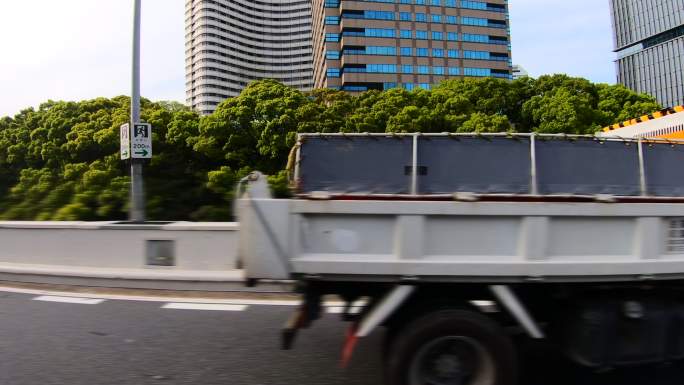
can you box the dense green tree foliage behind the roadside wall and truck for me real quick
[0,75,659,220]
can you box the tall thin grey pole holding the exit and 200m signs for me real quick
[128,0,145,222]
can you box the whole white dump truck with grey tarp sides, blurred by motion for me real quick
[238,133,684,385]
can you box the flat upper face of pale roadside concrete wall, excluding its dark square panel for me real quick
[0,222,239,273]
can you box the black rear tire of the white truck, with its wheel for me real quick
[385,309,517,385]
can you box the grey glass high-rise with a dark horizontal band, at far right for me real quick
[610,0,684,107]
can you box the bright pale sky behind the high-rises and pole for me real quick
[0,0,615,116]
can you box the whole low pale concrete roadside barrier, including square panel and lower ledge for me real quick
[0,222,243,288]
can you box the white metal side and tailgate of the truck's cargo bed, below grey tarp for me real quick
[240,199,684,282]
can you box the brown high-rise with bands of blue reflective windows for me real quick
[312,0,512,92]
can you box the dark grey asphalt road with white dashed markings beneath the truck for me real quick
[0,292,684,385]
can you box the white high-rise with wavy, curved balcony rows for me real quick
[185,0,313,114]
